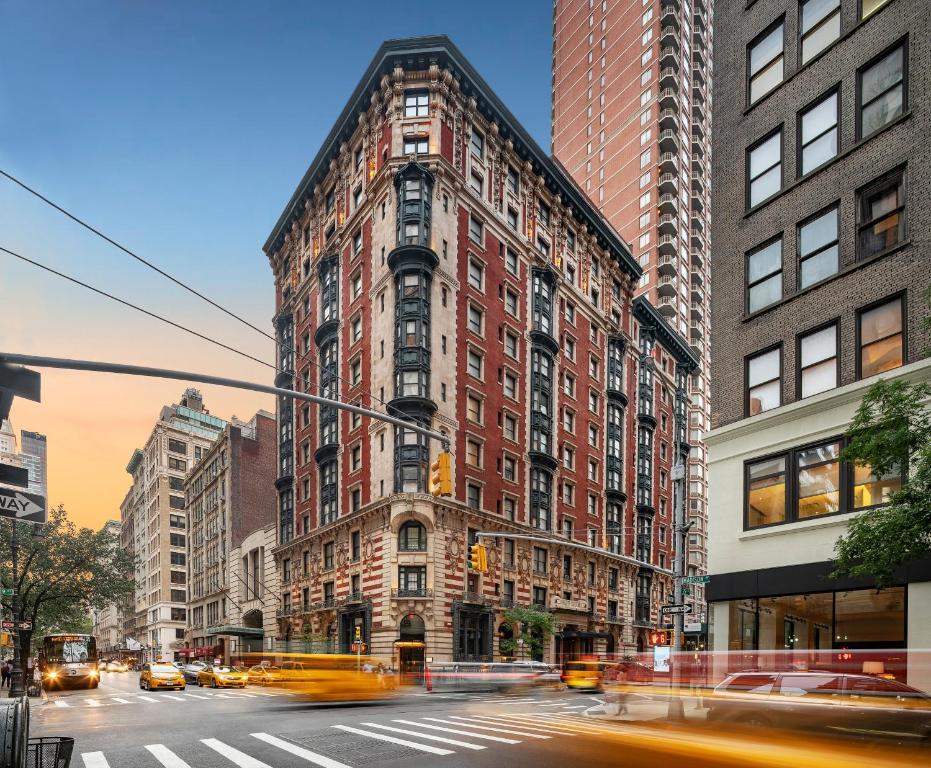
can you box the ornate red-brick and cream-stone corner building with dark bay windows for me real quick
[264,37,697,669]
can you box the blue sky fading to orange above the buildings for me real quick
[0,0,552,527]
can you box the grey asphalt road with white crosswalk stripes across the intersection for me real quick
[30,672,632,768]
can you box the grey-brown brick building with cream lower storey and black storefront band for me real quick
[706,0,931,687]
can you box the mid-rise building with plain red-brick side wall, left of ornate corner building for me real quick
[184,411,278,660]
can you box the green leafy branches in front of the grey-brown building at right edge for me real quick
[833,380,931,587]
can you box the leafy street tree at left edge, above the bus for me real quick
[0,506,135,673]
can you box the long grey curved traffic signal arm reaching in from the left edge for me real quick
[0,352,449,451]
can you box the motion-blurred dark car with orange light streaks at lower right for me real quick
[706,670,931,744]
